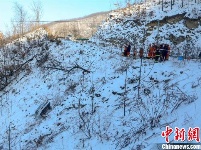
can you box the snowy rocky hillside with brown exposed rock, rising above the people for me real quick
[94,0,201,57]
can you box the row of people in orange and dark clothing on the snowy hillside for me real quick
[123,43,170,62]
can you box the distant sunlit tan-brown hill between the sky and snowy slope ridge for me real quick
[47,12,109,38]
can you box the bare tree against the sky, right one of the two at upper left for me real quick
[31,0,43,28]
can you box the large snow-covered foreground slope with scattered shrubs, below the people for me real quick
[0,0,201,150]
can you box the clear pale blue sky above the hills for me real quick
[0,0,124,32]
